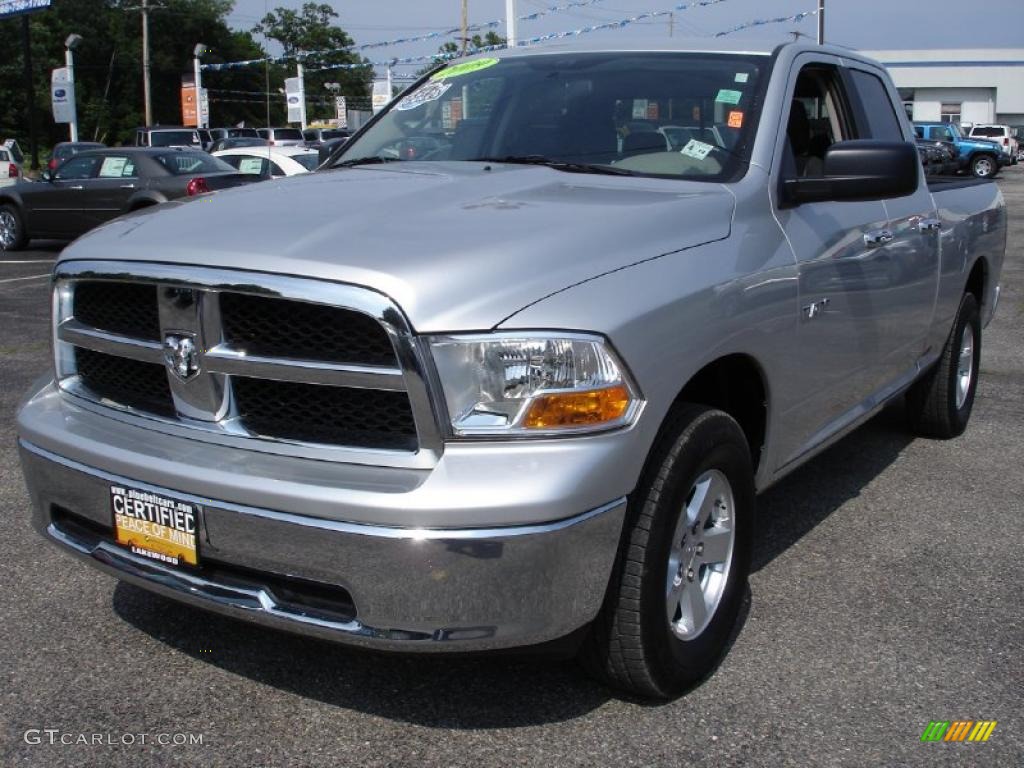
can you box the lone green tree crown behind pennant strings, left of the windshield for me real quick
[252,2,374,118]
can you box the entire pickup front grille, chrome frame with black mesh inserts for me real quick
[54,262,441,467]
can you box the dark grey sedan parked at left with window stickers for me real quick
[0,147,259,251]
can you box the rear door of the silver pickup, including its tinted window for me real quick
[847,62,939,378]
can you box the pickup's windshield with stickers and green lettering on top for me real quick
[335,52,769,181]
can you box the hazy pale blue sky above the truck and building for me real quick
[229,0,1024,78]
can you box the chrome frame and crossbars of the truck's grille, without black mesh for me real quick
[53,261,444,469]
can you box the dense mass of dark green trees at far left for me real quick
[0,0,268,146]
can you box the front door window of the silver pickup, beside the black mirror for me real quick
[783,65,850,177]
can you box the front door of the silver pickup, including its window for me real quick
[771,53,891,466]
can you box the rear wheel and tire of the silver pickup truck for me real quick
[906,293,981,439]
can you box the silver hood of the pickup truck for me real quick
[61,162,734,332]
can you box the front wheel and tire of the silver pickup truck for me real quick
[582,404,755,699]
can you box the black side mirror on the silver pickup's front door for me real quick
[782,139,921,207]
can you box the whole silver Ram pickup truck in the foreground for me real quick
[17,41,1007,697]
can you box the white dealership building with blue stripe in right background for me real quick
[866,48,1024,125]
